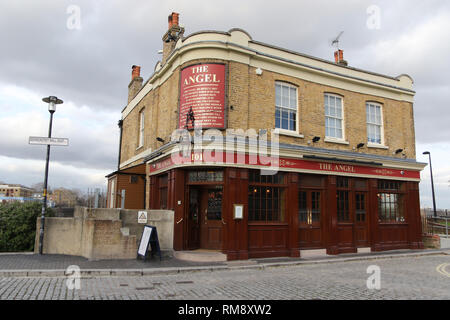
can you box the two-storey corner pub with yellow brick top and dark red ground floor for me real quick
[107,13,425,260]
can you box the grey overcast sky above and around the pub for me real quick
[0,0,450,208]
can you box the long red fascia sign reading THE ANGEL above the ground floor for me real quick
[150,151,420,180]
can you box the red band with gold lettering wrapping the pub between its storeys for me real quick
[147,150,420,182]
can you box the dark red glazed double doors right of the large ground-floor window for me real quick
[298,190,323,249]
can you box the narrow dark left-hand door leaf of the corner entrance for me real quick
[187,187,200,250]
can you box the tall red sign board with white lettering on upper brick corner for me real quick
[178,63,225,129]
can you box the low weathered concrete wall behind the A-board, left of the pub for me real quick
[35,207,174,260]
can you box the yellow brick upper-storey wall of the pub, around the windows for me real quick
[121,59,415,167]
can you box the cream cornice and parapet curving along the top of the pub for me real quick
[122,29,415,119]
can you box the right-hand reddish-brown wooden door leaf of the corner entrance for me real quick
[199,186,223,250]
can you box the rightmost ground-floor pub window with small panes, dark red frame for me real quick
[377,180,405,223]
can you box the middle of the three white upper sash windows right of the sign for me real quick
[325,93,344,139]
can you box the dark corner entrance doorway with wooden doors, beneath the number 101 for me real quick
[188,185,223,250]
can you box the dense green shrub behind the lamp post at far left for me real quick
[0,201,54,252]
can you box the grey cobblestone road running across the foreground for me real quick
[0,255,450,300]
